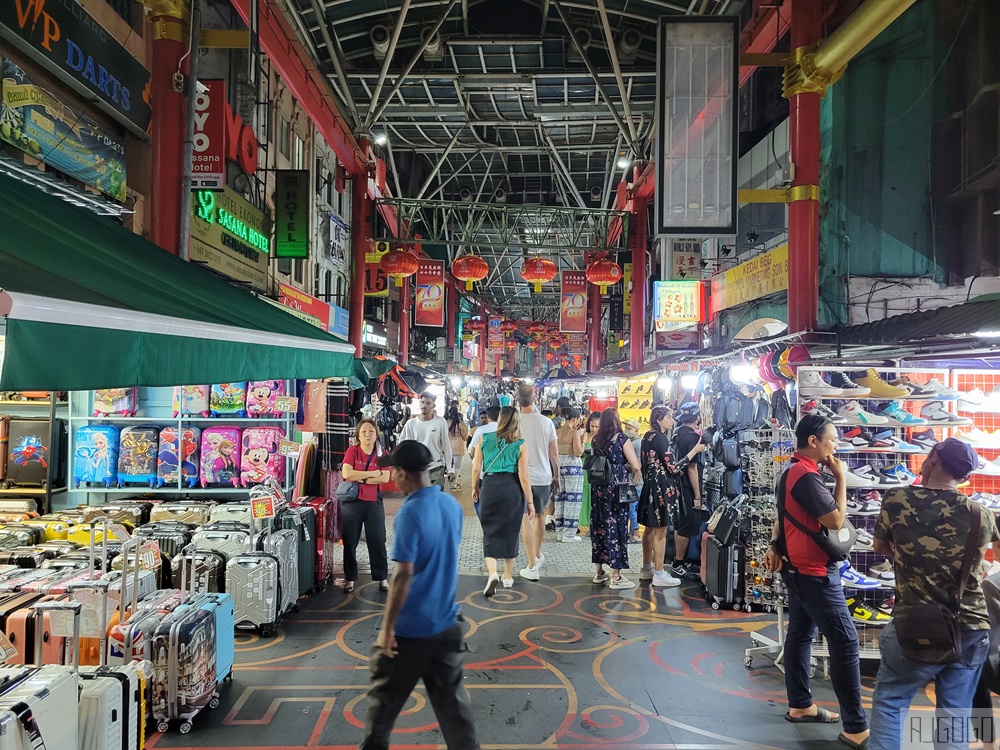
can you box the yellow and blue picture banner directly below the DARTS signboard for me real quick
[0,58,125,202]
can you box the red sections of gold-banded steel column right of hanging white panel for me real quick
[788,0,823,333]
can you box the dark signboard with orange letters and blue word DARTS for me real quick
[0,0,152,135]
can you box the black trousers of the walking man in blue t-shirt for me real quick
[360,623,479,750]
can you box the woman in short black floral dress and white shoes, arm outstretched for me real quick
[639,406,705,586]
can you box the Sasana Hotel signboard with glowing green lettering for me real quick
[189,188,271,290]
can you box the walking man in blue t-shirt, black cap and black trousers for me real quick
[360,440,479,750]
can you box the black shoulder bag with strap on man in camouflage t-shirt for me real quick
[892,507,982,664]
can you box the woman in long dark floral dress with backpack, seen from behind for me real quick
[587,409,642,589]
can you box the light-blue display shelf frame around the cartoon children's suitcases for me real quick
[67,384,295,505]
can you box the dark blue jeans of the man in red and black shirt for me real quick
[782,571,868,734]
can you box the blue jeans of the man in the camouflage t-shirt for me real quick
[868,624,990,750]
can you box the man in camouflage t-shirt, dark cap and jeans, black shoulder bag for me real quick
[869,438,1000,750]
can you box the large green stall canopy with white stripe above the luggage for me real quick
[0,175,354,390]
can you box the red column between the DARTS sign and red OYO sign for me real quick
[148,0,191,255]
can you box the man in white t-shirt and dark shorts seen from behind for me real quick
[517,384,559,581]
